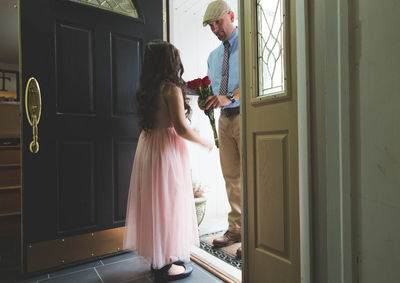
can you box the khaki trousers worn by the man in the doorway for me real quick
[218,115,242,233]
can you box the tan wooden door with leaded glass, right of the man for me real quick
[241,0,300,283]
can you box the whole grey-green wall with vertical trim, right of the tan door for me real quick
[309,0,400,283]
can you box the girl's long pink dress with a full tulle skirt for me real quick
[124,92,199,269]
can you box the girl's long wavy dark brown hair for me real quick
[136,40,191,131]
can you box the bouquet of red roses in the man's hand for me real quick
[187,76,219,148]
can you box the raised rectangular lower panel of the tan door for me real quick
[254,133,288,258]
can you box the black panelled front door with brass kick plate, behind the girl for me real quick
[20,0,163,272]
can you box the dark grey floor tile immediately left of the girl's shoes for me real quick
[96,257,150,283]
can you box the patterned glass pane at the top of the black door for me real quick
[70,0,139,19]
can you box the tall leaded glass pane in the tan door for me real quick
[257,0,286,96]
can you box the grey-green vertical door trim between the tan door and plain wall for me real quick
[307,0,353,283]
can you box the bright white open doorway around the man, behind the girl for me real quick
[169,0,242,281]
